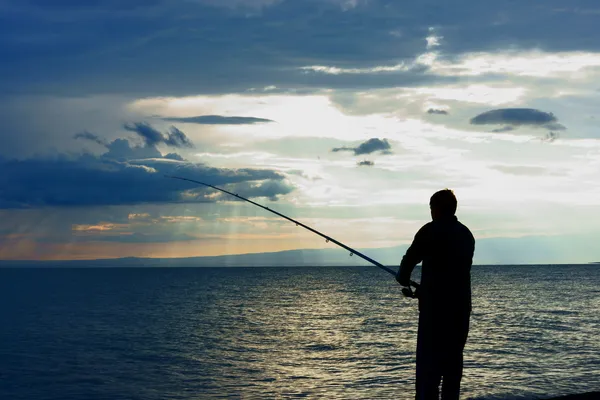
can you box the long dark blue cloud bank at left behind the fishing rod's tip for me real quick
[0,139,293,208]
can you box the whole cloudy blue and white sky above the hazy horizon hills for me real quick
[0,0,600,263]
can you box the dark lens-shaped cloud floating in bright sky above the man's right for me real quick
[471,108,558,126]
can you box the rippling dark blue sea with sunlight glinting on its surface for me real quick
[0,265,600,400]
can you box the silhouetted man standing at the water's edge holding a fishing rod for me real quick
[396,189,475,400]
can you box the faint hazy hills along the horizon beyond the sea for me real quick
[0,236,600,267]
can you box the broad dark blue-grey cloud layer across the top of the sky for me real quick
[0,0,600,95]
